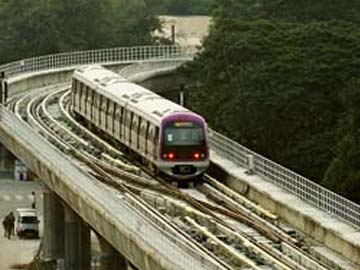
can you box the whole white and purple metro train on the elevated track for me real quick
[71,65,209,181]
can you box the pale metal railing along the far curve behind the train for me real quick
[0,45,193,77]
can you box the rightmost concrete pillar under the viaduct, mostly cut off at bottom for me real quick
[97,235,128,270]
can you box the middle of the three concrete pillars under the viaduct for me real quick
[65,206,91,270]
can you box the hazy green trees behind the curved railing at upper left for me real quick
[0,0,162,63]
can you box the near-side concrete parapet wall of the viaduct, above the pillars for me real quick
[0,108,186,270]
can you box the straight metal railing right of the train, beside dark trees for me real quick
[210,130,360,229]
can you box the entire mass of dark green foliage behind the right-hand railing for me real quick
[184,0,360,202]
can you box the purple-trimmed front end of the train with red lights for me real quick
[157,112,209,180]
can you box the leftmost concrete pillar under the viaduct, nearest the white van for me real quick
[43,188,65,261]
